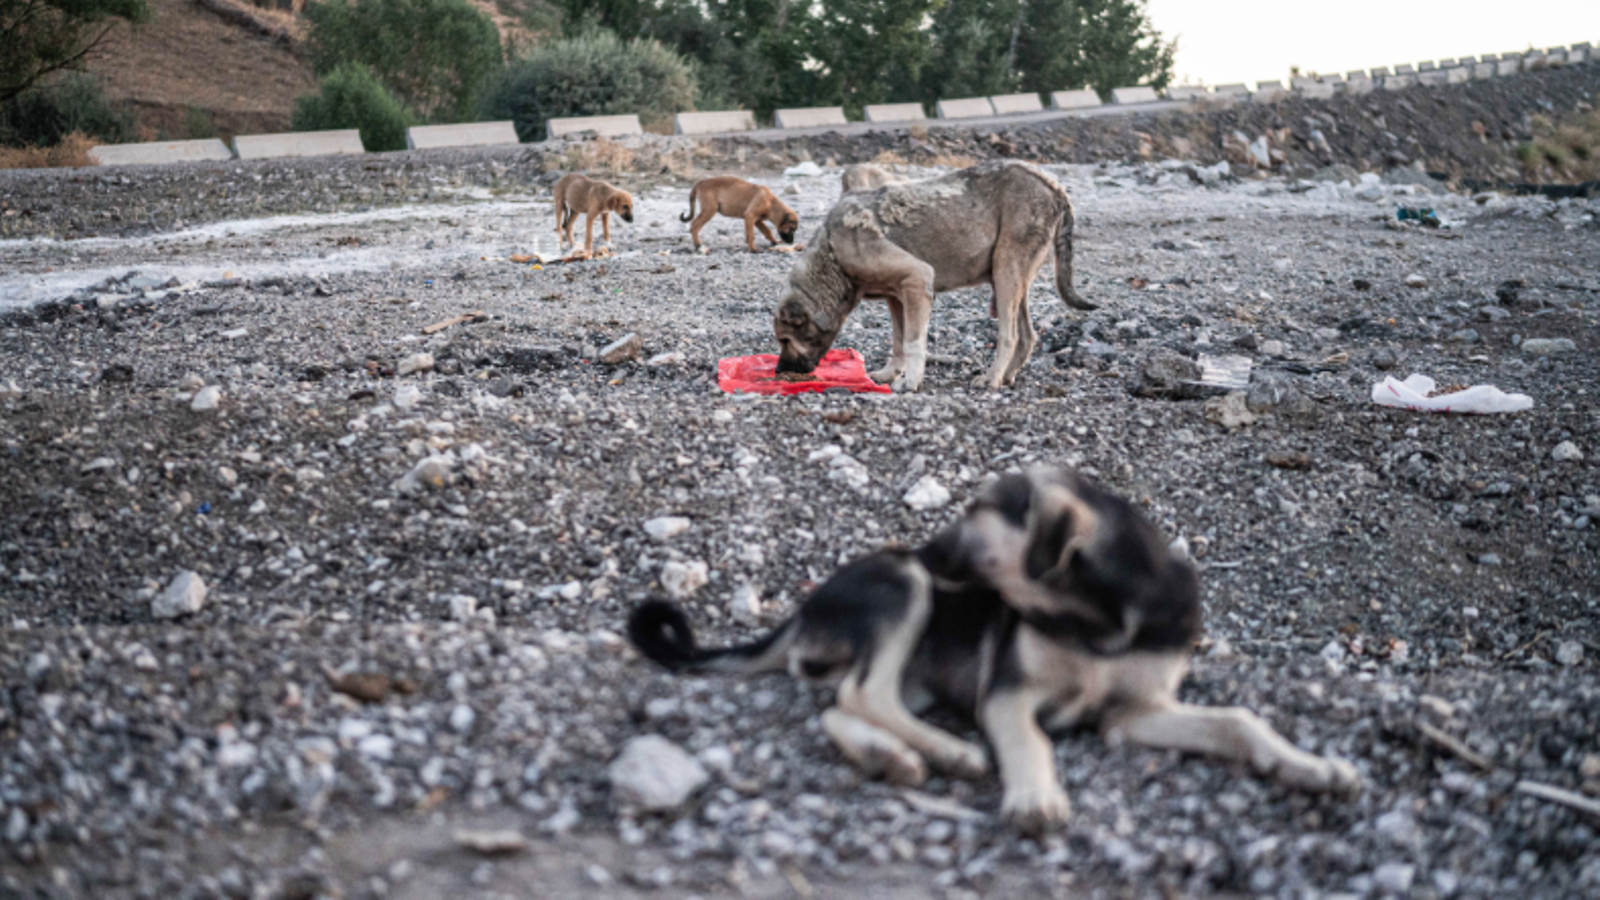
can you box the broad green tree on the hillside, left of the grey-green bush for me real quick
[300,0,504,122]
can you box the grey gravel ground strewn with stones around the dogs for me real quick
[0,150,1600,898]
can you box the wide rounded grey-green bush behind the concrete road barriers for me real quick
[480,30,696,141]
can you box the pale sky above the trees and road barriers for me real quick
[1149,0,1600,85]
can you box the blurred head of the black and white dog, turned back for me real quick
[952,466,1200,650]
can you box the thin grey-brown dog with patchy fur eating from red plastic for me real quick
[773,160,1094,391]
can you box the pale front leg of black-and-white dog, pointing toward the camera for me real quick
[979,687,1072,833]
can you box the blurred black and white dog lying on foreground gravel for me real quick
[629,468,1360,831]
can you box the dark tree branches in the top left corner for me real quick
[0,0,149,102]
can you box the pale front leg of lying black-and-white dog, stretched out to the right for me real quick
[1106,703,1362,794]
